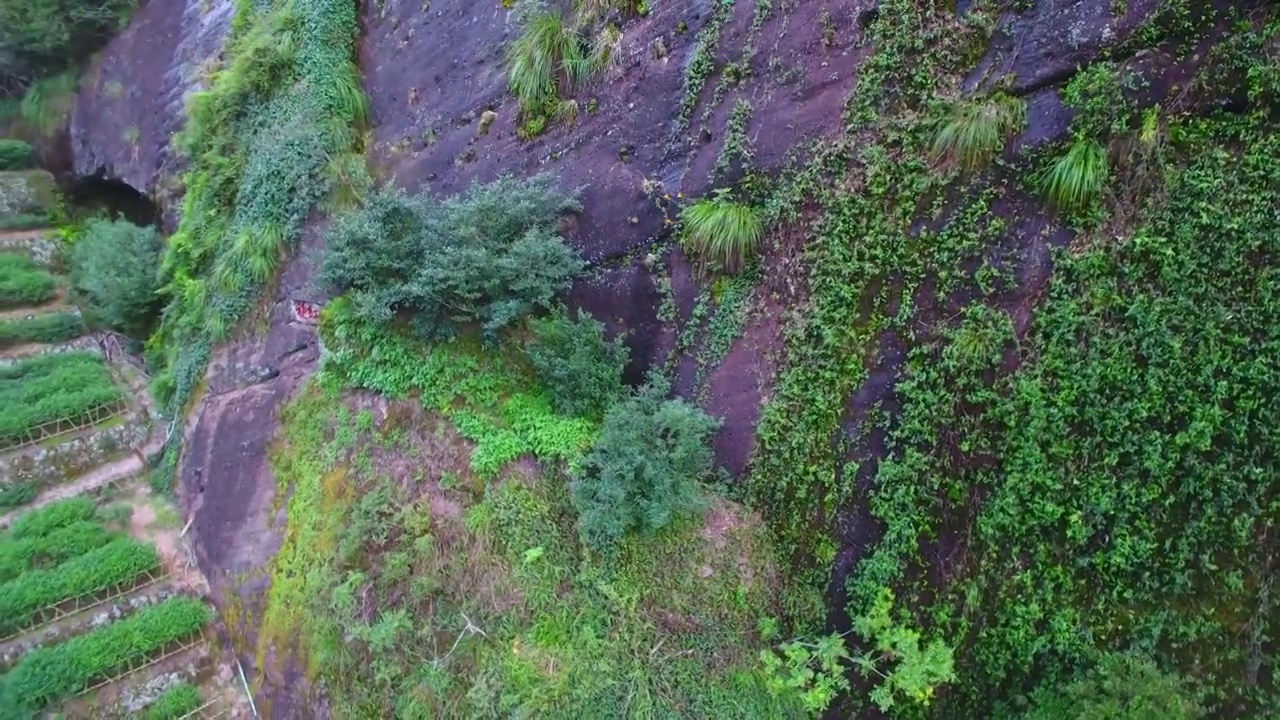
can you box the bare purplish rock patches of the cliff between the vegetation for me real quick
[72,0,1259,716]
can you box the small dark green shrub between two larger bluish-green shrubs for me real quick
[525,310,628,418]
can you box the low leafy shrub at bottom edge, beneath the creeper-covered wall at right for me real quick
[1023,652,1204,720]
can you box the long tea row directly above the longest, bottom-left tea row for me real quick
[0,538,159,634]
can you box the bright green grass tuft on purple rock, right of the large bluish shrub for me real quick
[680,190,764,273]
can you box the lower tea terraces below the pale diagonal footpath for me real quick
[0,497,243,720]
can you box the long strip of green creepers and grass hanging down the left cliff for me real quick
[147,0,369,489]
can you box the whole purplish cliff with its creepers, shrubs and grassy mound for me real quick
[0,0,1280,719]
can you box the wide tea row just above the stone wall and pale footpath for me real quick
[0,352,123,446]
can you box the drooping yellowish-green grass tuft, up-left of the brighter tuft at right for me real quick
[933,94,1027,170]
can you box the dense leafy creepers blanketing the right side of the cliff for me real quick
[748,3,1280,717]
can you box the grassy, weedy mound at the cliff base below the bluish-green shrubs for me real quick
[259,325,799,717]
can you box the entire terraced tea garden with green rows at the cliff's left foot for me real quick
[0,165,252,720]
